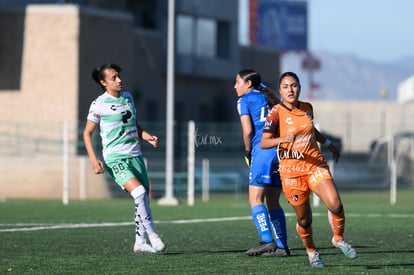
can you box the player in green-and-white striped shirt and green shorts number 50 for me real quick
[83,64,165,253]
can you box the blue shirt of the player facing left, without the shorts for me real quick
[237,90,268,152]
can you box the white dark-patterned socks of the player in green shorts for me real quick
[131,185,155,242]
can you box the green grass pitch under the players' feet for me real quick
[0,190,414,274]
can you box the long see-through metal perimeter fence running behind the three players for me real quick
[0,122,414,205]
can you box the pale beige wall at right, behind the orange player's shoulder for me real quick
[311,100,414,152]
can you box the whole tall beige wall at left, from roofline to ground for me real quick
[0,5,109,199]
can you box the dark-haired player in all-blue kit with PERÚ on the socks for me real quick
[234,69,290,256]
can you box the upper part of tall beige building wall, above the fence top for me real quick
[0,6,79,126]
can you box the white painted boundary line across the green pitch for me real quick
[0,213,414,233]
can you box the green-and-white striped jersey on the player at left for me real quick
[87,91,142,162]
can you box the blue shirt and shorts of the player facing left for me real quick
[237,90,281,187]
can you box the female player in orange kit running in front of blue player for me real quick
[261,72,357,267]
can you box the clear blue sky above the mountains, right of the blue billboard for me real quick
[308,0,414,62]
